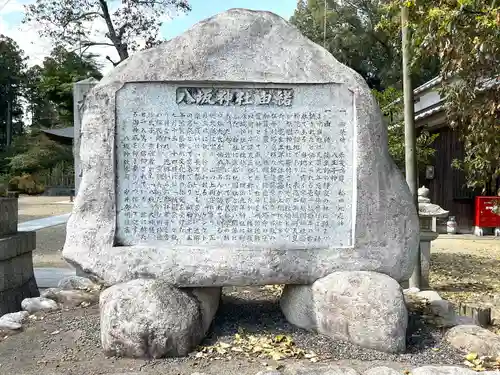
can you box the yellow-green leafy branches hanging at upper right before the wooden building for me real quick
[379,0,500,192]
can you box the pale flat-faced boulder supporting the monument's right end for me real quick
[281,271,408,353]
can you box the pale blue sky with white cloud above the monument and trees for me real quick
[0,0,297,70]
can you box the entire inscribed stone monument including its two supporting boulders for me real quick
[63,9,419,357]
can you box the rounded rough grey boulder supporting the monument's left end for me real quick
[99,279,220,358]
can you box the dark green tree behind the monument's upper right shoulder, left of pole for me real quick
[290,0,438,91]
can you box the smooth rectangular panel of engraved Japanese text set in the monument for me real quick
[116,83,356,249]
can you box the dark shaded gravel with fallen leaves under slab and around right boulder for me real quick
[199,287,457,363]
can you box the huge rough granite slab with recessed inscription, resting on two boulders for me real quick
[63,9,419,286]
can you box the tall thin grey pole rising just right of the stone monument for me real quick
[401,0,422,288]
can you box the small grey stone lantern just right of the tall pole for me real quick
[418,186,449,289]
